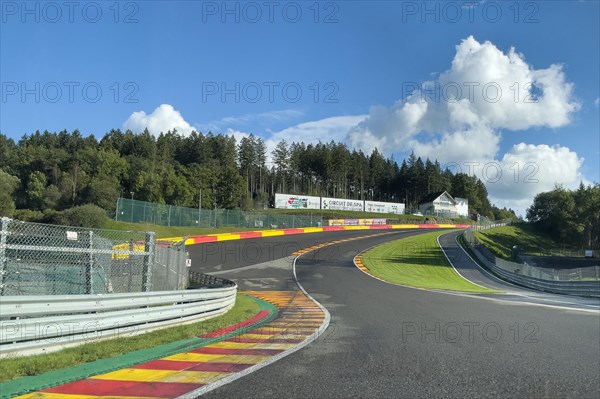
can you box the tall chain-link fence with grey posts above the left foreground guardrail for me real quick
[0,218,187,296]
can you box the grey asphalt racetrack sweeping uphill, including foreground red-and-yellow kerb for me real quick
[14,226,600,399]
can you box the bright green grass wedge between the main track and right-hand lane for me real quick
[363,232,495,293]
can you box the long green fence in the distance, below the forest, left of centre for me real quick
[115,198,323,229]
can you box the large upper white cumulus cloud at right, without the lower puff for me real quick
[347,36,581,159]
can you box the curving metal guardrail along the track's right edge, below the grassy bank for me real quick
[463,229,600,297]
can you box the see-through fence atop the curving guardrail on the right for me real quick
[463,229,600,281]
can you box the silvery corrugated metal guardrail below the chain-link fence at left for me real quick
[0,284,237,357]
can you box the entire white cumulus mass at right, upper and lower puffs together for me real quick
[346,36,583,213]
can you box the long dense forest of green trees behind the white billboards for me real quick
[0,129,515,219]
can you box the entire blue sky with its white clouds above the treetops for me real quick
[0,1,600,216]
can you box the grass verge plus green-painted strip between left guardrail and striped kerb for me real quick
[0,294,277,399]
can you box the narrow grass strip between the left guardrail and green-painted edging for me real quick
[0,295,260,381]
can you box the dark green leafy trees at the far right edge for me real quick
[527,183,600,249]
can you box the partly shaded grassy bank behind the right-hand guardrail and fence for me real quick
[475,223,569,260]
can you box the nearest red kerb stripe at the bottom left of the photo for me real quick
[42,379,205,398]
